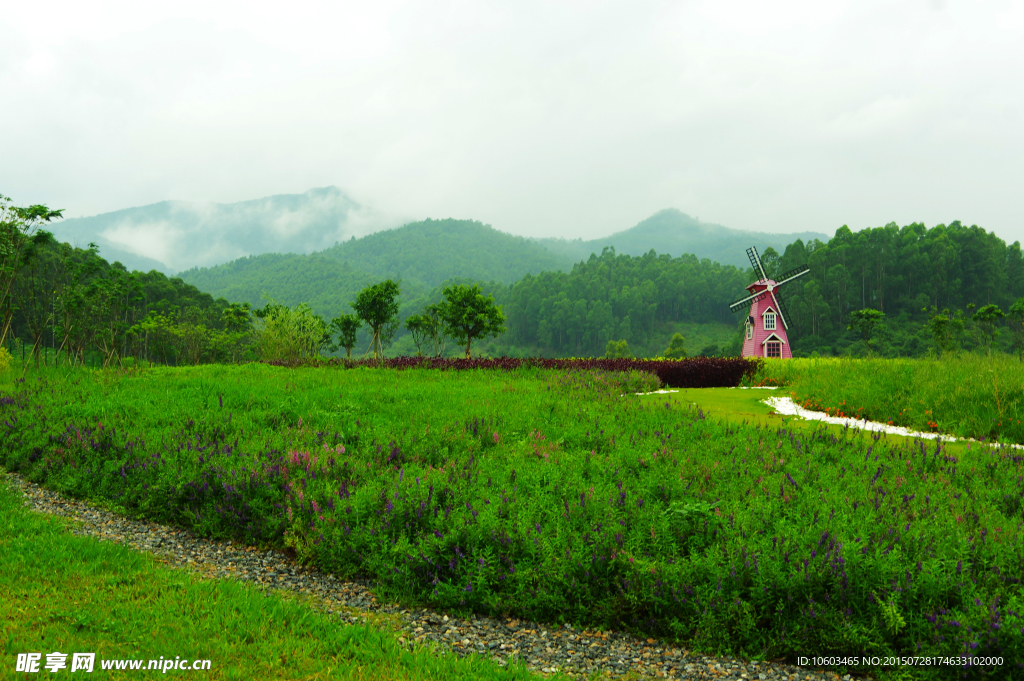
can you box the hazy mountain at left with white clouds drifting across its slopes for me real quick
[51,186,395,274]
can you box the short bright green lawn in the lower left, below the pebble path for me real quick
[0,480,552,680]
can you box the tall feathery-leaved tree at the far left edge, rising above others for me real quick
[0,195,63,345]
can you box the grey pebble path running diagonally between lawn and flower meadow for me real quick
[7,473,850,681]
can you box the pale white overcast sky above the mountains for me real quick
[0,0,1024,242]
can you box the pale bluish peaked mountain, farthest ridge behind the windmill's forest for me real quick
[535,208,829,269]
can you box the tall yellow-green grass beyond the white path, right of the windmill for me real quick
[754,353,1024,443]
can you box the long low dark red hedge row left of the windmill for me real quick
[266,357,758,388]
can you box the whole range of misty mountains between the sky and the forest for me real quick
[52,186,828,274]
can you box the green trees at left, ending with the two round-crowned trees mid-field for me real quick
[0,196,505,367]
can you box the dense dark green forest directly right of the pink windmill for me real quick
[762,221,1024,356]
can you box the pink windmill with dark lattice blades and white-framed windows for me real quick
[729,247,811,357]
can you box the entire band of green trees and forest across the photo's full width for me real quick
[8,191,1024,366]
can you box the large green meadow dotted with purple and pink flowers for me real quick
[0,365,1024,678]
